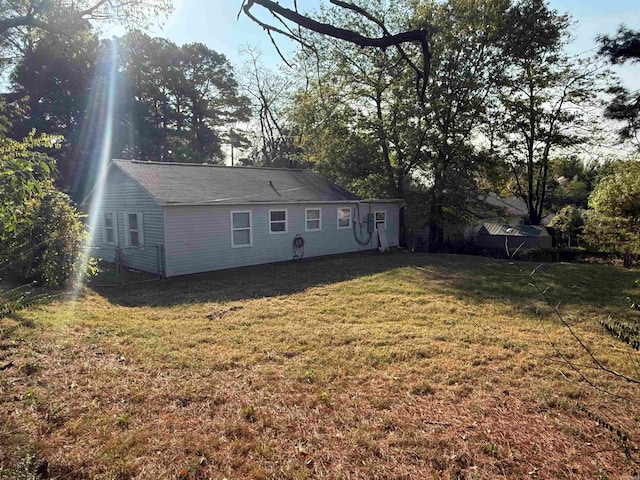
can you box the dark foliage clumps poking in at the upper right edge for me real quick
[598,26,640,148]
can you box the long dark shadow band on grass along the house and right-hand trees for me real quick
[95,252,640,312]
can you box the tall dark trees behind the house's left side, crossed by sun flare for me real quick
[4,29,250,199]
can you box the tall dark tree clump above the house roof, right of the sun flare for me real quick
[116,32,250,162]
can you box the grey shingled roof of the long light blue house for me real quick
[113,160,360,205]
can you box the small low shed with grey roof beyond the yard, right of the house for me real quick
[476,223,552,250]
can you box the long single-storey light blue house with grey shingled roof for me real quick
[89,160,401,277]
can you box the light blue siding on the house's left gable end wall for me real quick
[92,166,164,273]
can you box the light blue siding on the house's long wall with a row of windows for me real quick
[162,203,399,276]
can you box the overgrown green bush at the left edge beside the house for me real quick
[0,132,91,288]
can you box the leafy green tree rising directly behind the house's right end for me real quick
[295,0,424,198]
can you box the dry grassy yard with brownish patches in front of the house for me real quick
[0,253,640,480]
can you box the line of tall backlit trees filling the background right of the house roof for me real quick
[241,0,639,253]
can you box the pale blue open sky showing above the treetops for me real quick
[150,0,640,90]
